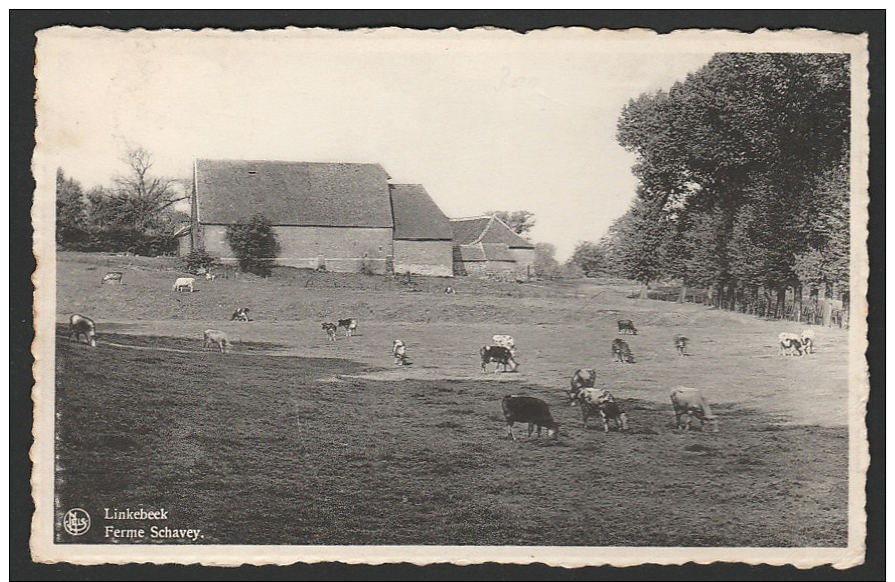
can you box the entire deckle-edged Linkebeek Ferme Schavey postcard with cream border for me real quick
[31,21,869,568]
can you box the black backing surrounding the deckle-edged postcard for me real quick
[9,10,886,580]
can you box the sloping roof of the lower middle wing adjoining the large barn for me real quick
[390,184,453,240]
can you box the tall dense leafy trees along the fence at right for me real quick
[581,53,850,322]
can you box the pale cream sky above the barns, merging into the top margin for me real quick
[37,28,714,260]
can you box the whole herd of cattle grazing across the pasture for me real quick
[69,271,815,440]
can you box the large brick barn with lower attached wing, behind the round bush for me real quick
[180,160,452,276]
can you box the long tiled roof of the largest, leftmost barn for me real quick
[195,160,393,228]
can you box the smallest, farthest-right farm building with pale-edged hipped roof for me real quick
[451,216,535,276]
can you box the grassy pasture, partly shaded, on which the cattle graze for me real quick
[56,253,848,546]
